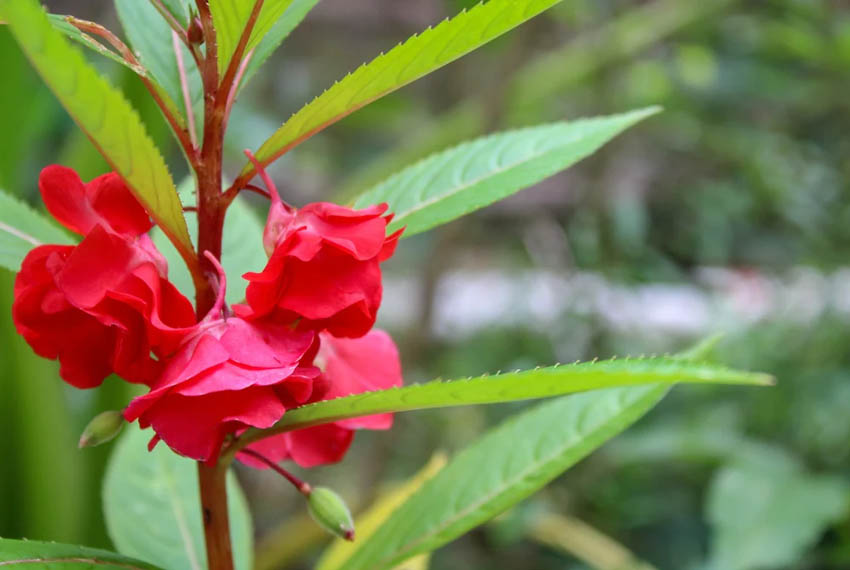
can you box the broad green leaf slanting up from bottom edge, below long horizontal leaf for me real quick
[341,386,669,570]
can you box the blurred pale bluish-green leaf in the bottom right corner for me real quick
[708,454,850,570]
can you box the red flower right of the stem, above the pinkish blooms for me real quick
[236,201,401,337]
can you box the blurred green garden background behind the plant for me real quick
[0,0,850,570]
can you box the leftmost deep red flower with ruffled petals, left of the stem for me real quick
[12,166,195,388]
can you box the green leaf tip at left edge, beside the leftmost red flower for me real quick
[0,186,73,271]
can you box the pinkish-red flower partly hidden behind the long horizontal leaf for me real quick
[237,330,402,469]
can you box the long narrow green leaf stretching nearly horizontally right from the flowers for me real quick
[241,358,772,441]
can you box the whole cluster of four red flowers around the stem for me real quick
[12,166,401,467]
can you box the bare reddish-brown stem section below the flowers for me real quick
[198,463,233,570]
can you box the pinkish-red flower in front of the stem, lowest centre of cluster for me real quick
[124,317,319,463]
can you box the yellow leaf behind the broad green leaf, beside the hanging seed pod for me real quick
[316,452,448,570]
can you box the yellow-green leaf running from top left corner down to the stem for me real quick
[0,0,196,264]
